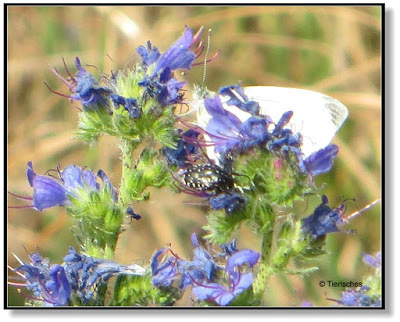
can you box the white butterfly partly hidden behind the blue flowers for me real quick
[194,86,349,158]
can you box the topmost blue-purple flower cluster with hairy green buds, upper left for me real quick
[45,27,211,147]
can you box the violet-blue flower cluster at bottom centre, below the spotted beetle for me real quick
[151,234,260,306]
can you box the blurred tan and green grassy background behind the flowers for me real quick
[7,6,382,306]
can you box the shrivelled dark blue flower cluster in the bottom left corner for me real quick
[9,247,145,306]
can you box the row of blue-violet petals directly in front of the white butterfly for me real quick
[199,85,338,177]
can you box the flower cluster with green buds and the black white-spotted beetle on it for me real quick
[164,85,338,214]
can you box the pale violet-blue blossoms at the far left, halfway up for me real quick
[21,161,117,211]
